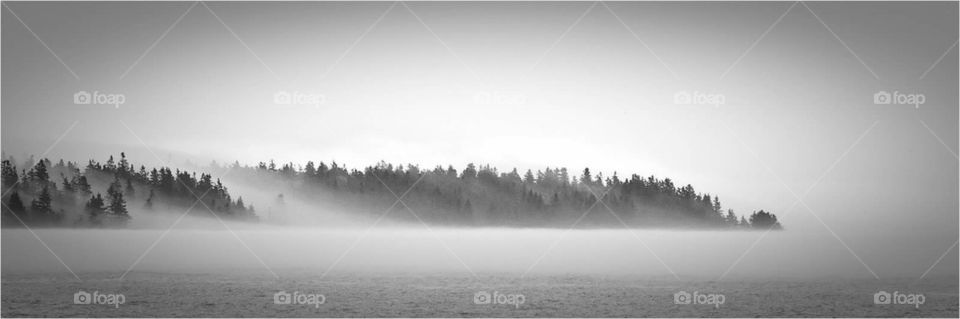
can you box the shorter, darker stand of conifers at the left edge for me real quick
[0,153,257,227]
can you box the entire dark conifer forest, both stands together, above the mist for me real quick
[2,153,782,229]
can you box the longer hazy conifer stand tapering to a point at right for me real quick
[223,161,782,229]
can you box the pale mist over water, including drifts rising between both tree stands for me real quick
[0,156,958,280]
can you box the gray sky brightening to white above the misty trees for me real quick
[2,2,958,242]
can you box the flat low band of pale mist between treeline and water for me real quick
[2,220,957,280]
